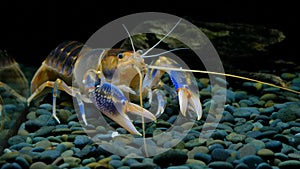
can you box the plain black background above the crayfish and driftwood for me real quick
[0,0,299,66]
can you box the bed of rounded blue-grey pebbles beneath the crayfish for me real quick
[0,73,300,169]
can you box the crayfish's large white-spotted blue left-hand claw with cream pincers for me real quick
[84,71,156,135]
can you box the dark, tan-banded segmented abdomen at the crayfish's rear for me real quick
[45,41,83,76]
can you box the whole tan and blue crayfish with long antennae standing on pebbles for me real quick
[0,18,300,139]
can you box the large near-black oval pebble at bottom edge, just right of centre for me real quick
[153,149,188,166]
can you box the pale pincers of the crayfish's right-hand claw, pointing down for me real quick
[178,87,202,120]
